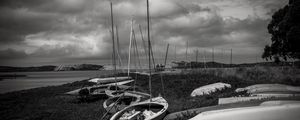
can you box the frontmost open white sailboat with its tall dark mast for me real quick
[110,0,169,120]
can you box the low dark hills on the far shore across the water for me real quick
[0,64,104,72]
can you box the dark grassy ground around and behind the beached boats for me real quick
[0,67,300,120]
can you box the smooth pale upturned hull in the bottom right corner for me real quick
[190,101,300,120]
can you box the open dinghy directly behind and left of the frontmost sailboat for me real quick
[103,91,150,113]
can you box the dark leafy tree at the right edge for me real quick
[262,0,300,62]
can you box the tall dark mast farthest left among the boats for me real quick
[110,2,117,85]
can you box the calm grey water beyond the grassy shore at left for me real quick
[0,70,116,93]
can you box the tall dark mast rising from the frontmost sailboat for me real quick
[147,0,152,102]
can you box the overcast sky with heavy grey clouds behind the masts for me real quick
[0,0,288,66]
